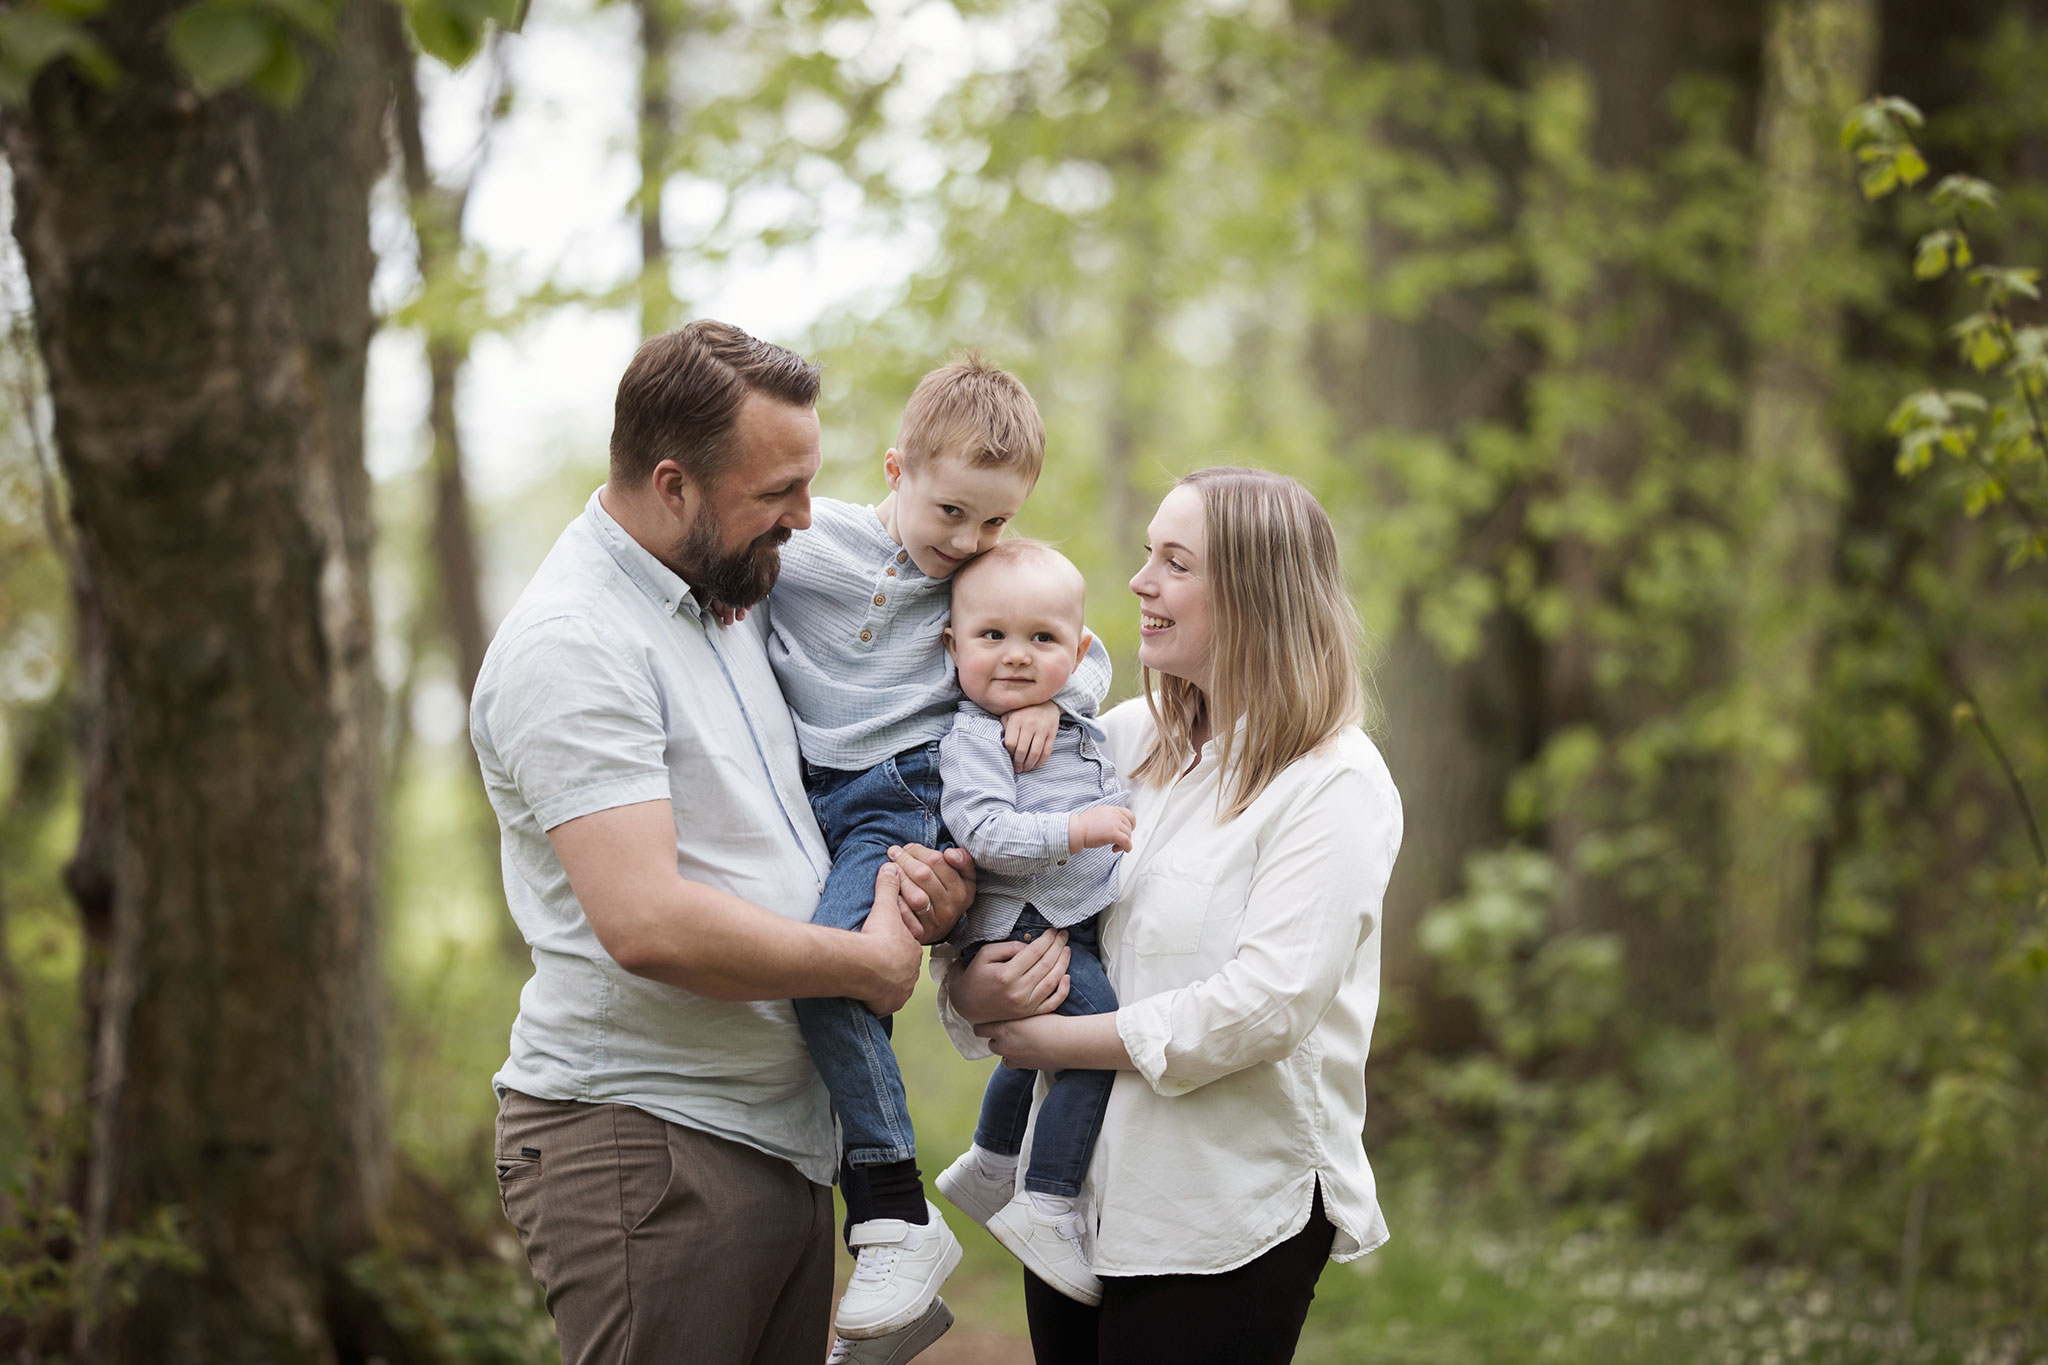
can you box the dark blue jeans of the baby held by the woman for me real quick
[961,905,1116,1199]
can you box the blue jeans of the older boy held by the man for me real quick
[795,741,944,1166]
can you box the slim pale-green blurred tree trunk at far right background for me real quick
[1716,0,1876,1009]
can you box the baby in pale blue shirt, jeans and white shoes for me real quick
[938,540,1133,1304]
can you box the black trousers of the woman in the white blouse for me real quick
[1024,1189,1337,1365]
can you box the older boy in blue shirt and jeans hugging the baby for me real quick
[768,354,1108,1340]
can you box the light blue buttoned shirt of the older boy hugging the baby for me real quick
[764,497,1110,772]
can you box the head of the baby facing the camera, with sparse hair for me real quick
[946,561,1087,716]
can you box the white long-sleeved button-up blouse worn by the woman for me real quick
[942,698,1401,1275]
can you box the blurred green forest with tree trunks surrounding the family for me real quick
[0,0,2048,1365]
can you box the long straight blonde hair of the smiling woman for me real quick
[1130,467,1366,821]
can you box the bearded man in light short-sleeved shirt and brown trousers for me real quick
[471,321,973,1365]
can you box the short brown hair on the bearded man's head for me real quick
[612,319,817,487]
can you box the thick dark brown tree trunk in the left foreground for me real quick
[6,0,383,1363]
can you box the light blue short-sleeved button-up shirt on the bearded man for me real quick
[469,493,838,1185]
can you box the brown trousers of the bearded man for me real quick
[498,1091,834,1365]
